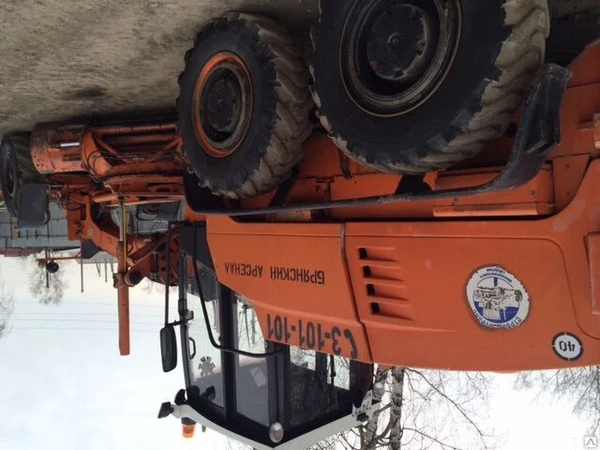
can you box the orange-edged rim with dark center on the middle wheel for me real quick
[193,52,252,158]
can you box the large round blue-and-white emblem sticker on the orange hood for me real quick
[467,266,529,329]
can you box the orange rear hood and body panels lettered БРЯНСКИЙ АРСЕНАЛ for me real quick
[207,45,600,371]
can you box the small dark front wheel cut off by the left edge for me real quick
[0,133,44,217]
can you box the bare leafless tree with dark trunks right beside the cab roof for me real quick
[317,367,497,450]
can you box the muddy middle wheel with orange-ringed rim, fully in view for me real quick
[177,14,313,199]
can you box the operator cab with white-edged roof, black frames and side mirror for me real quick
[159,227,374,449]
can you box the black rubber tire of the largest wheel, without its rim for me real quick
[311,0,549,174]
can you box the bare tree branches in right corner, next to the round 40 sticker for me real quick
[515,366,600,436]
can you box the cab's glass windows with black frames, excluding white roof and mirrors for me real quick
[175,250,371,445]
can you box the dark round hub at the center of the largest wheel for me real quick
[367,4,436,83]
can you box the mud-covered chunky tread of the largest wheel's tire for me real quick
[310,0,550,174]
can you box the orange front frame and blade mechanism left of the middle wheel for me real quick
[31,123,188,355]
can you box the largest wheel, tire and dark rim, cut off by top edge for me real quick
[311,0,549,174]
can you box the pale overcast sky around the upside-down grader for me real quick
[0,257,586,450]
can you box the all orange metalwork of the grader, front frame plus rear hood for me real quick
[32,41,600,371]
